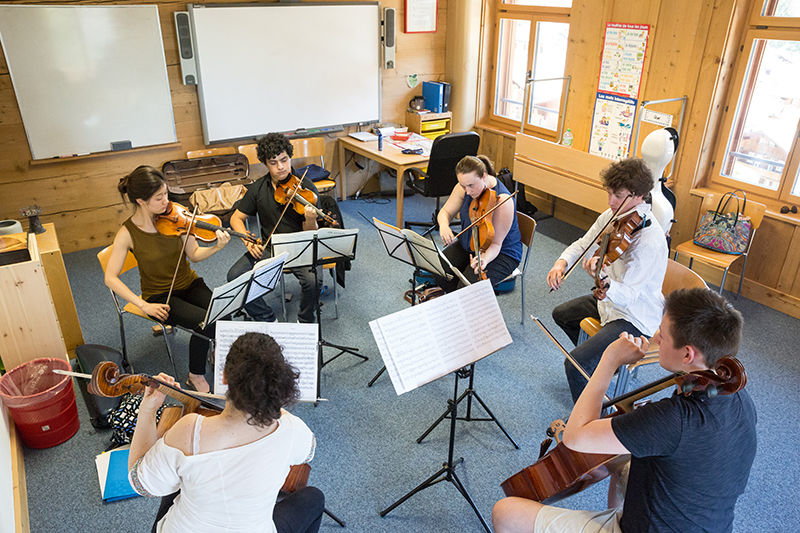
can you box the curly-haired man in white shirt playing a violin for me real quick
[547,159,669,401]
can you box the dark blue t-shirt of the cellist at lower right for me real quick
[611,390,756,533]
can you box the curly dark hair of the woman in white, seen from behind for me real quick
[225,333,300,427]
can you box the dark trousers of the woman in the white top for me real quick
[152,487,325,533]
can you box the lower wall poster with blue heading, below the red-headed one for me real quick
[589,93,636,161]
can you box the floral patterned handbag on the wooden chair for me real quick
[694,190,753,255]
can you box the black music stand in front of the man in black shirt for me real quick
[272,228,369,396]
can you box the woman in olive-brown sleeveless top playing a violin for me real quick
[105,166,230,392]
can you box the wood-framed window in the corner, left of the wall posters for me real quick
[491,0,572,138]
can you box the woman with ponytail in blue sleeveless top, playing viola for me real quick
[436,155,522,291]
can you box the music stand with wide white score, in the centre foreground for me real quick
[370,281,512,532]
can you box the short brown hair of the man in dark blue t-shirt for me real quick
[664,288,743,367]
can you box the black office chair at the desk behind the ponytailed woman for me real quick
[405,131,481,234]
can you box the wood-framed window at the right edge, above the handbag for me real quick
[713,0,800,202]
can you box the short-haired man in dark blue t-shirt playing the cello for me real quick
[492,289,756,533]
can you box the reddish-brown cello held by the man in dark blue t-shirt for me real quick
[500,357,747,504]
